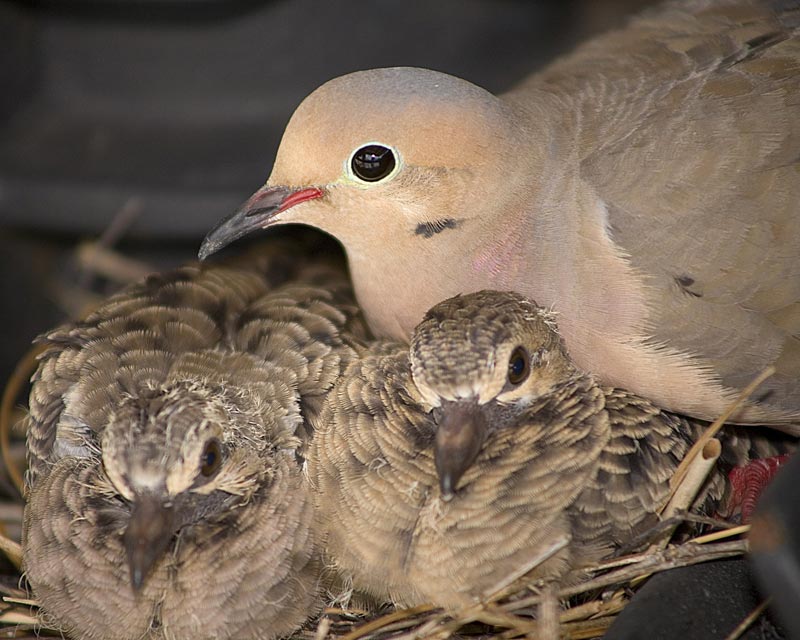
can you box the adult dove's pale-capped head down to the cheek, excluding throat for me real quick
[201,67,525,257]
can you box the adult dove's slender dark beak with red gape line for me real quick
[197,186,323,260]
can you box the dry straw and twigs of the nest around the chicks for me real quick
[0,235,772,640]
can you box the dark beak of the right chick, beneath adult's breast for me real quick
[434,402,487,501]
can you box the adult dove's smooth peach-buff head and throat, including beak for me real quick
[200,67,546,338]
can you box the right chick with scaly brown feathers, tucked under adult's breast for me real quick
[309,292,785,608]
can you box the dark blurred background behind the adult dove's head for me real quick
[0,0,646,380]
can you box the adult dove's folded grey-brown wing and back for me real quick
[507,0,800,430]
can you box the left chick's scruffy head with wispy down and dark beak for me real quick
[101,352,299,590]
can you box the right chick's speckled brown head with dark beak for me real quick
[411,291,575,499]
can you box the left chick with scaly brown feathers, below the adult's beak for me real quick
[23,248,360,640]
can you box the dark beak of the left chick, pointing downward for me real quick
[124,494,175,591]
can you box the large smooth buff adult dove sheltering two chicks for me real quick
[200,0,800,433]
